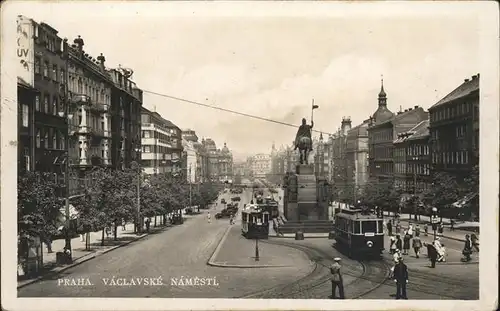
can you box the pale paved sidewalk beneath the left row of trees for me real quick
[17,216,170,288]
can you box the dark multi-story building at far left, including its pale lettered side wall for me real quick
[18,16,68,184]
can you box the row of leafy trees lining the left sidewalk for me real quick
[18,164,220,249]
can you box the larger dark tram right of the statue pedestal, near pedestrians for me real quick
[334,209,384,257]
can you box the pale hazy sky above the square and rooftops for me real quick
[11,2,479,158]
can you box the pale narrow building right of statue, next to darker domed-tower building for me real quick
[345,120,369,193]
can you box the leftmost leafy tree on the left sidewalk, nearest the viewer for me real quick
[17,172,64,245]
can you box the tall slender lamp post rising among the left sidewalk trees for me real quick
[59,108,73,264]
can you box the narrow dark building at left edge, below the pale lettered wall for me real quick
[17,77,39,175]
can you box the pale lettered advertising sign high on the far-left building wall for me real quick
[17,15,35,87]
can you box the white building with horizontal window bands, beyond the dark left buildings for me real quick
[141,107,172,174]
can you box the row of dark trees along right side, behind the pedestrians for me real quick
[332,166,479,218]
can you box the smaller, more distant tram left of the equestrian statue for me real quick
[241,204,269,239]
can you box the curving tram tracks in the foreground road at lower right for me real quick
[238,239,479,299]
